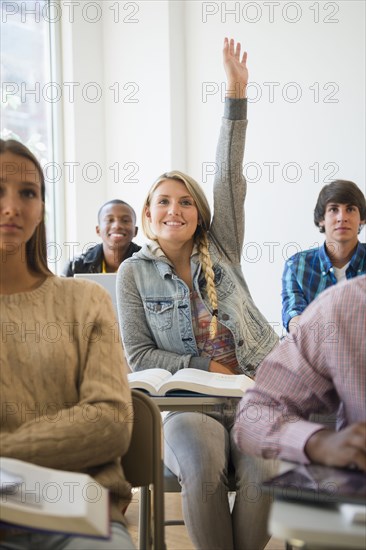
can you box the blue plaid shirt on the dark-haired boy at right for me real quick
[282,242,366,330]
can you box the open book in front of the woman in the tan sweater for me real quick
[0,457,109,538]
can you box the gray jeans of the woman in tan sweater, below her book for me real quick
[0,522,135,550]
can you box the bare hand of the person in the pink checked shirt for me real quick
[305,422,366,471]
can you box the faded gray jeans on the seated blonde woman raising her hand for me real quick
[164,411,279,550]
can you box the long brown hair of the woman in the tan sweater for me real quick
[0,139,53,275]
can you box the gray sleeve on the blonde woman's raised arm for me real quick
[210,99,248,265]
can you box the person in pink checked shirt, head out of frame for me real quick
[234,275,366,470]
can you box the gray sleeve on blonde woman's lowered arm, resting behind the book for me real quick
[116,260,210,374]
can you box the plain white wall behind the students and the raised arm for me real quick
[59,0,365,332]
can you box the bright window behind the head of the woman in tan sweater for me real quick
[0,0,62,269]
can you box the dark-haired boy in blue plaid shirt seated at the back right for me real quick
[282,180,366,331]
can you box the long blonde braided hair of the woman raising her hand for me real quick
[141,170,218,338]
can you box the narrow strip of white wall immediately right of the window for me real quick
[60,2,107,253]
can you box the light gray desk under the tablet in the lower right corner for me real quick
[269,499,366,550]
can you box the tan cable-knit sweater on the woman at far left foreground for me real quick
[0,276,132,522]
